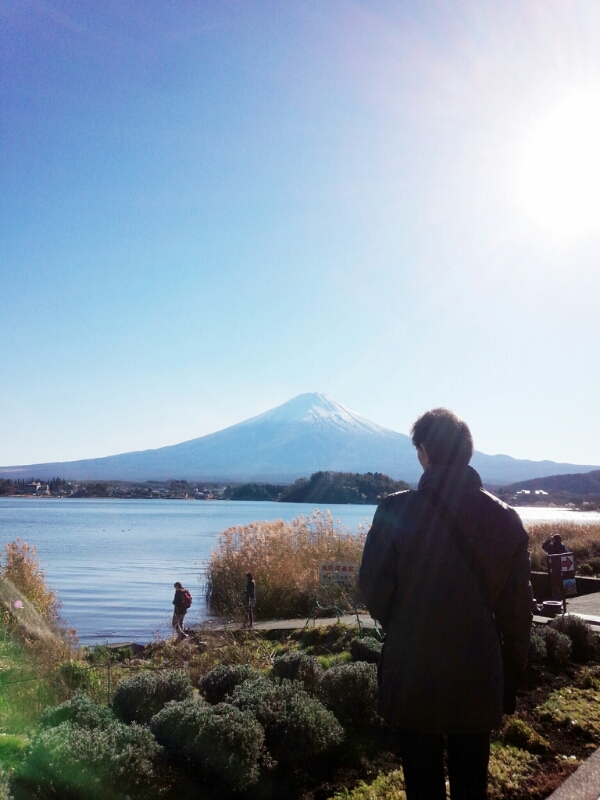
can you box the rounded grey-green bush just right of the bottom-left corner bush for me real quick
[150,699,264,790]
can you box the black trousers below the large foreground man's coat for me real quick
[398,729,490,800]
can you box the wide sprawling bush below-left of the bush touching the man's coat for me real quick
[231,677,344,766]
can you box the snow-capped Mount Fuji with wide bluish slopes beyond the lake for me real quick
[0,392,598,486]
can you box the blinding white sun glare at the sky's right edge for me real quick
[520,92,600,237]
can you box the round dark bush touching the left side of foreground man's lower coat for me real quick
[318,661,377,725]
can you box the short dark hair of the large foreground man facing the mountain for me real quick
[410,408,473,466]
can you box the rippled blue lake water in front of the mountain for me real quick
[0,497,600,644]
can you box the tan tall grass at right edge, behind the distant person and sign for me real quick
[525,520,600,573]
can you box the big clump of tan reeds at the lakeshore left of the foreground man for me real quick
[207,510,366,619]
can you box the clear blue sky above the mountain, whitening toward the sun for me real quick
[0,0,600,465]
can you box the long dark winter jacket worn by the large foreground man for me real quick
[359,465,532,733]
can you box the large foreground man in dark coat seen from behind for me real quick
[359,408,532,800]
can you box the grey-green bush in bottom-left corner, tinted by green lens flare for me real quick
[14,721,161,800]
